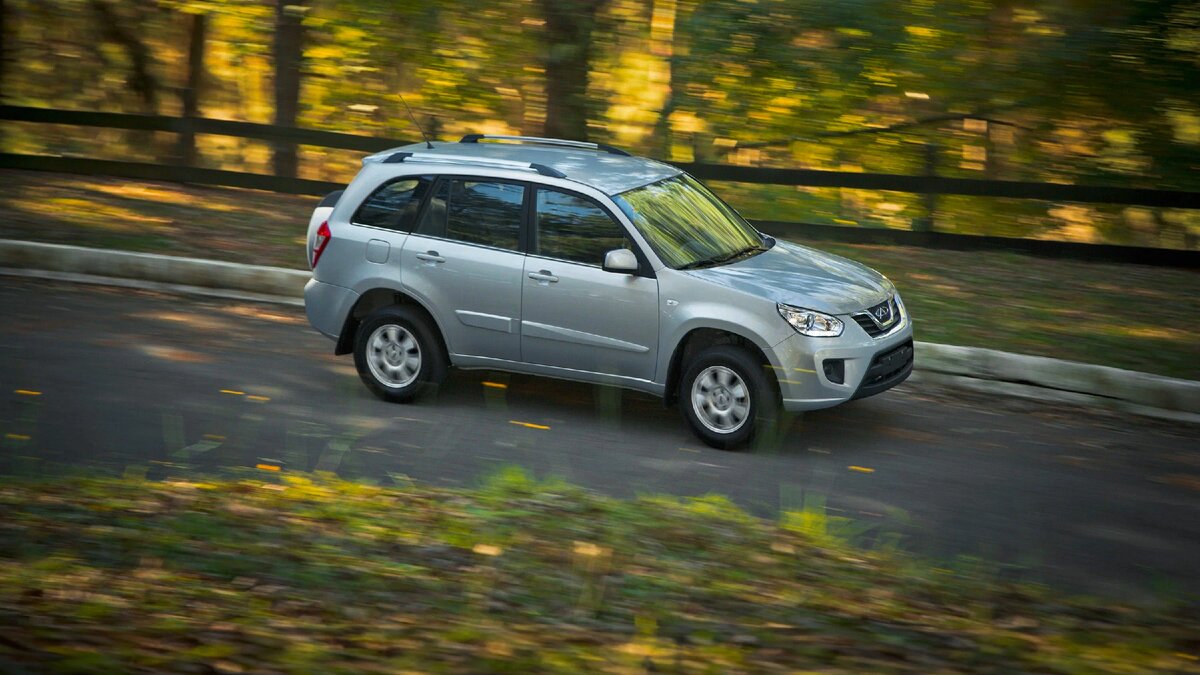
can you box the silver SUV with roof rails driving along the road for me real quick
[305,135,913,448]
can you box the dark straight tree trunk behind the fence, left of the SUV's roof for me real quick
[272,0,305,178]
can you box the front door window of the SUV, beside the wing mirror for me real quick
[533,189,630,265]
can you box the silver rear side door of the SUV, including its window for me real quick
[401,177,527,362]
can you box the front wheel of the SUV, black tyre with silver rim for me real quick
[679,345,779,450]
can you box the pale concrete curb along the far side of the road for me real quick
[0,241,1200,423]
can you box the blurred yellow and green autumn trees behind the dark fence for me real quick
[0,0,1200,250]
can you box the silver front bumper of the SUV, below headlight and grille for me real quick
[768,306,913,412]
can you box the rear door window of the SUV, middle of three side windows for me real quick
[416,179,526,251]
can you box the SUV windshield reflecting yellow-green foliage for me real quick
[614,174,767,269]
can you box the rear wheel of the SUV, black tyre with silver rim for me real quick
[354,305,446,404]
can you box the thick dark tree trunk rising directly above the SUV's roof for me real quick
[538,0,605,141]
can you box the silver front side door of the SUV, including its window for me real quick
[521,186,659,381]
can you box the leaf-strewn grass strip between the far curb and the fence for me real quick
[0,171,1200,380]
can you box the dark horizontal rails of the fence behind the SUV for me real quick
[0,106,1200,268]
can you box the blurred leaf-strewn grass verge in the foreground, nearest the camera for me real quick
[0,470,1200,673]
